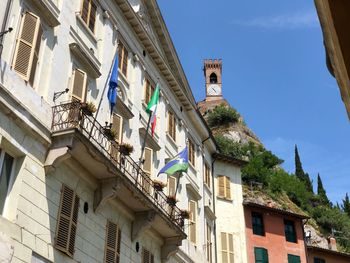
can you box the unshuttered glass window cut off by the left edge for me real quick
[0,149,14,214]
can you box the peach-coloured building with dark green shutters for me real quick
[243,201,308,263]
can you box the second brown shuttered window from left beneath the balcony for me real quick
[104,221,121,263]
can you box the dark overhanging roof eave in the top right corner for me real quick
[315,0,350,118]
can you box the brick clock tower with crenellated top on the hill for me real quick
[204,59,223,101]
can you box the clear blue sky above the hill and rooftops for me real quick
[158,0,350,203]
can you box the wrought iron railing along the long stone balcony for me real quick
[52,102,184,231]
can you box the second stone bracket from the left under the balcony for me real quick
[94,177,121,212]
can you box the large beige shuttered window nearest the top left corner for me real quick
[13,12,42,85]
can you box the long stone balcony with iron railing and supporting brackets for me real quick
[45,102,186,260]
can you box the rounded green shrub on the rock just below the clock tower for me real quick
[207,104,240,127]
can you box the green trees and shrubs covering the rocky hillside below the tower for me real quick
[206,105,350,252]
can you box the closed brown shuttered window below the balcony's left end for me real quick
[55,185,79,257]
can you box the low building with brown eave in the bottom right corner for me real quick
[307,246,350,263]
